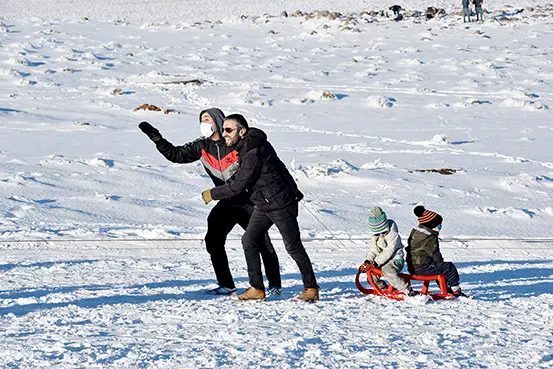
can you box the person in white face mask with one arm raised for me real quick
[139,108,281,295]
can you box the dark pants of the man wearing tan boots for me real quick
[242,202,319,289]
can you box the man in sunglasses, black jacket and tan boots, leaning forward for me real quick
[202,114,319,301]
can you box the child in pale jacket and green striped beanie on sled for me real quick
[359,206,416,296]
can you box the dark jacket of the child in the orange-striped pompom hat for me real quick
[406,225,444,273]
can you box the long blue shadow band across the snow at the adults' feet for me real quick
[0,260,553,316]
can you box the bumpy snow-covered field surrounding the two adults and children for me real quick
[0,0,553,368]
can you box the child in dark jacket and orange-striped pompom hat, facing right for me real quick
[406,205,467,297]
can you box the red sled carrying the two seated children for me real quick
[355,268,455,301]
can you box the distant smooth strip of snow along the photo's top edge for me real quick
[0,0,551,24]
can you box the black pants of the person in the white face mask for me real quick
[205,200,281,288]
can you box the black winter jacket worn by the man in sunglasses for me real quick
[211,128,303,211]
